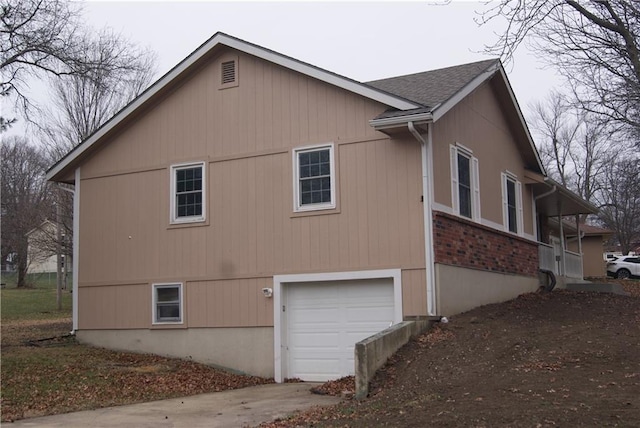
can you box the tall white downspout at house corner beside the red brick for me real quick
[407,122,437,316]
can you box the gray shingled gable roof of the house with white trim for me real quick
[46,32,544,182]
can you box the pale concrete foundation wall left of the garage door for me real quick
[76,327,274,378]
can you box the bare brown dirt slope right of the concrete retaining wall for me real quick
[271,291,640,427]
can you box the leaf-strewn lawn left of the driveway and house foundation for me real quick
[0,270,273,425]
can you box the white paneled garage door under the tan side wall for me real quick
[285,278,394,381]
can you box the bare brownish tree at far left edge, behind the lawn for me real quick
[0,137,51,287]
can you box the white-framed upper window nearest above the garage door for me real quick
[293,144,336,212]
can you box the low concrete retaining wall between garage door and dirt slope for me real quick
[354,319,432,399]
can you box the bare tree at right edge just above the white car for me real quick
[599,156,640,254]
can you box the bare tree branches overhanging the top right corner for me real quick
[480,0,640,140]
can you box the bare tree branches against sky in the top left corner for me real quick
[0,0,155,129]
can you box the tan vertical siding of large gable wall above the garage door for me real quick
[79,46,426,329]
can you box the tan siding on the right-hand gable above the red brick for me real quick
[433,78,533,235]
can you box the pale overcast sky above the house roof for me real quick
[3,0,561,140]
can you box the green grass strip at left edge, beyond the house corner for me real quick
[0,285,72,322]
